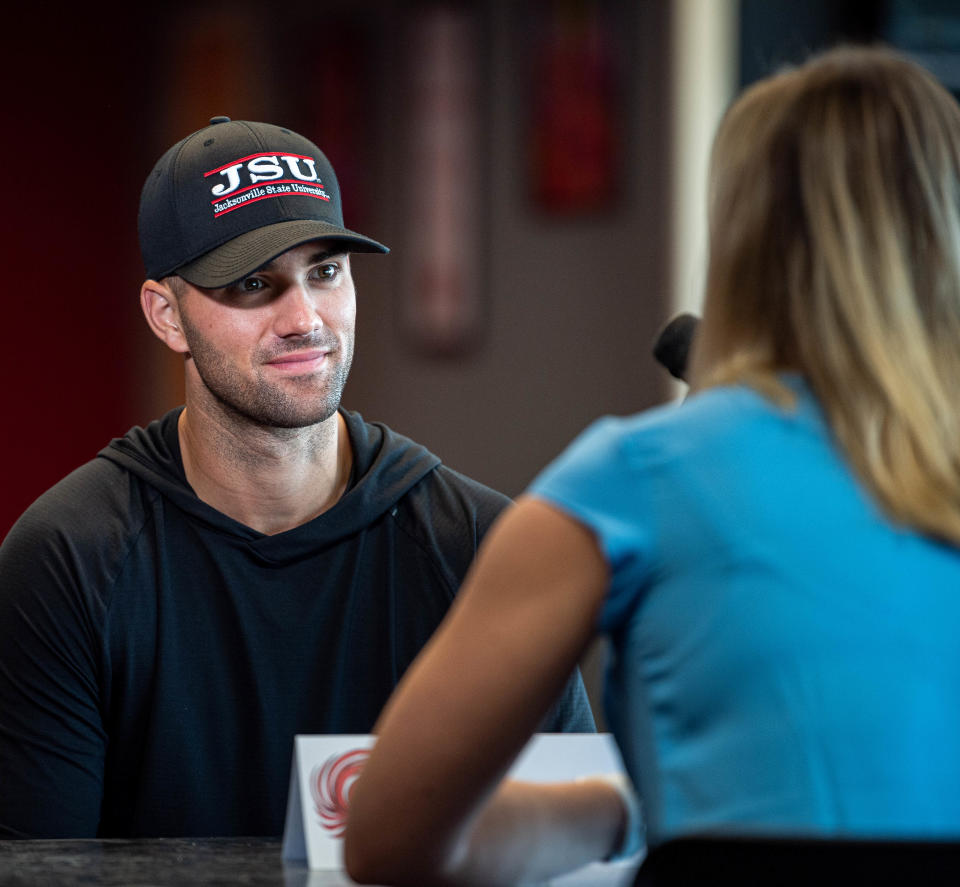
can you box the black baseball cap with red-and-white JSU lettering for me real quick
[137,117,389,288]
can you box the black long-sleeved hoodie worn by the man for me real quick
[0,409,593,837]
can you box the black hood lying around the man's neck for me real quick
[97,407,440,561]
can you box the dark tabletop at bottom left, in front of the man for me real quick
[0,838,354,887]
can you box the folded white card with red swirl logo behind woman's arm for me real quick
[283,733,640,884]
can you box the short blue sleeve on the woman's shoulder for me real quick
[528,417,651,630]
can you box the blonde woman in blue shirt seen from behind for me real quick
[346,48,960,884]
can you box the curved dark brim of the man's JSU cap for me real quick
[173,219,390,289]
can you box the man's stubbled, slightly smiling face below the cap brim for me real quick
[178,240,356,428]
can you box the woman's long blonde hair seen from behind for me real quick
[692,47,960,544]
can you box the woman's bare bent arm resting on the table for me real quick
[345,497,624,885]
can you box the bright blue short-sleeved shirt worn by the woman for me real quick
[531,377,960,844]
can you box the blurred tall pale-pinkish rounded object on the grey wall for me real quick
[394,3,486,357]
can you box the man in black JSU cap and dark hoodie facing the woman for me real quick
[0,117,593,837]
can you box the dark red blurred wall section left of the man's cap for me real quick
[0,7,143,538]
